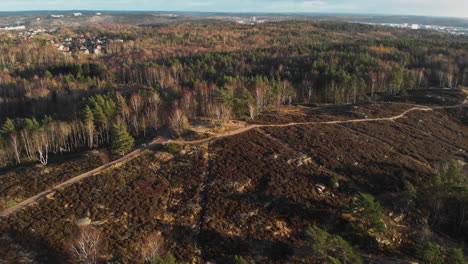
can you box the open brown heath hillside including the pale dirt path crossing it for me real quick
[0,89,468,263]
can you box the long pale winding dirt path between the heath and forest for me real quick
[0,102,468,219]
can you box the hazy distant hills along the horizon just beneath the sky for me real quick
[0,10,468,28]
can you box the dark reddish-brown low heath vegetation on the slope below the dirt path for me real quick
[0,90,468,263]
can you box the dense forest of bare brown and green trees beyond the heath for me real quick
[0,22,468,166]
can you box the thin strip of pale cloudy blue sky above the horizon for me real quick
[0,0,468,18]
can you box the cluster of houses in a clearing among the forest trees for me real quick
[50,36,109,55]
